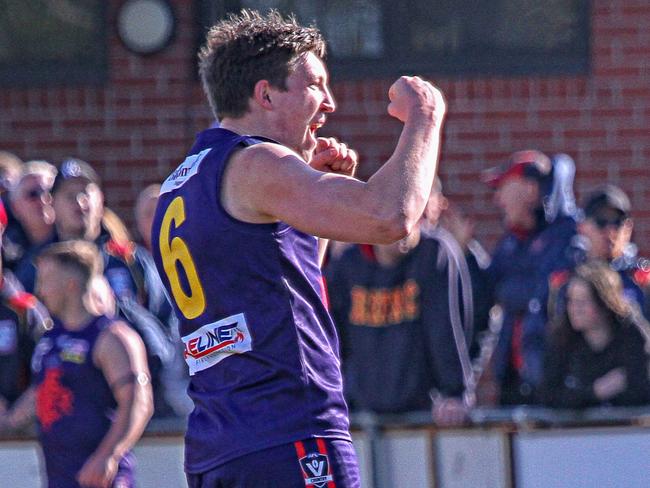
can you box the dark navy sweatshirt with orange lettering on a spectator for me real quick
[326,236,463,413]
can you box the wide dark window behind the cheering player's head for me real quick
[198,0,589,78]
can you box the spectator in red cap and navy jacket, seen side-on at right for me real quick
[486,150,576,404]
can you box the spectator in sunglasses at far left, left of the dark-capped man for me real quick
[3,161,56,293]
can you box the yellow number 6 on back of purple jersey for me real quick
[160,197,205,320]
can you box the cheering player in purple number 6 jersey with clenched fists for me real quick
[152,11,445,488]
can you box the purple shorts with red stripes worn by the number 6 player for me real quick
[187,438,361,488]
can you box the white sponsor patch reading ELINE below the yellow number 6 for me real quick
[182,313,253,376]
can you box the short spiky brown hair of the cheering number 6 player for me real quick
[194,9,325,119]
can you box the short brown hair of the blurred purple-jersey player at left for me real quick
[38,240,104,285]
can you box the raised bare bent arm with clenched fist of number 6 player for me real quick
[221,77,445,243]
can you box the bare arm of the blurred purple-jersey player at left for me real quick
[78,322,153,487]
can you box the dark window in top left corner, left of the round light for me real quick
[0,0,107,86]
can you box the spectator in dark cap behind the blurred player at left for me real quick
[52,159,174,416]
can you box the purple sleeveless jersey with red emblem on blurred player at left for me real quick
[32,316,135,488]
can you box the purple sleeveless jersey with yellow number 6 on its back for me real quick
[152,129,350,473]
